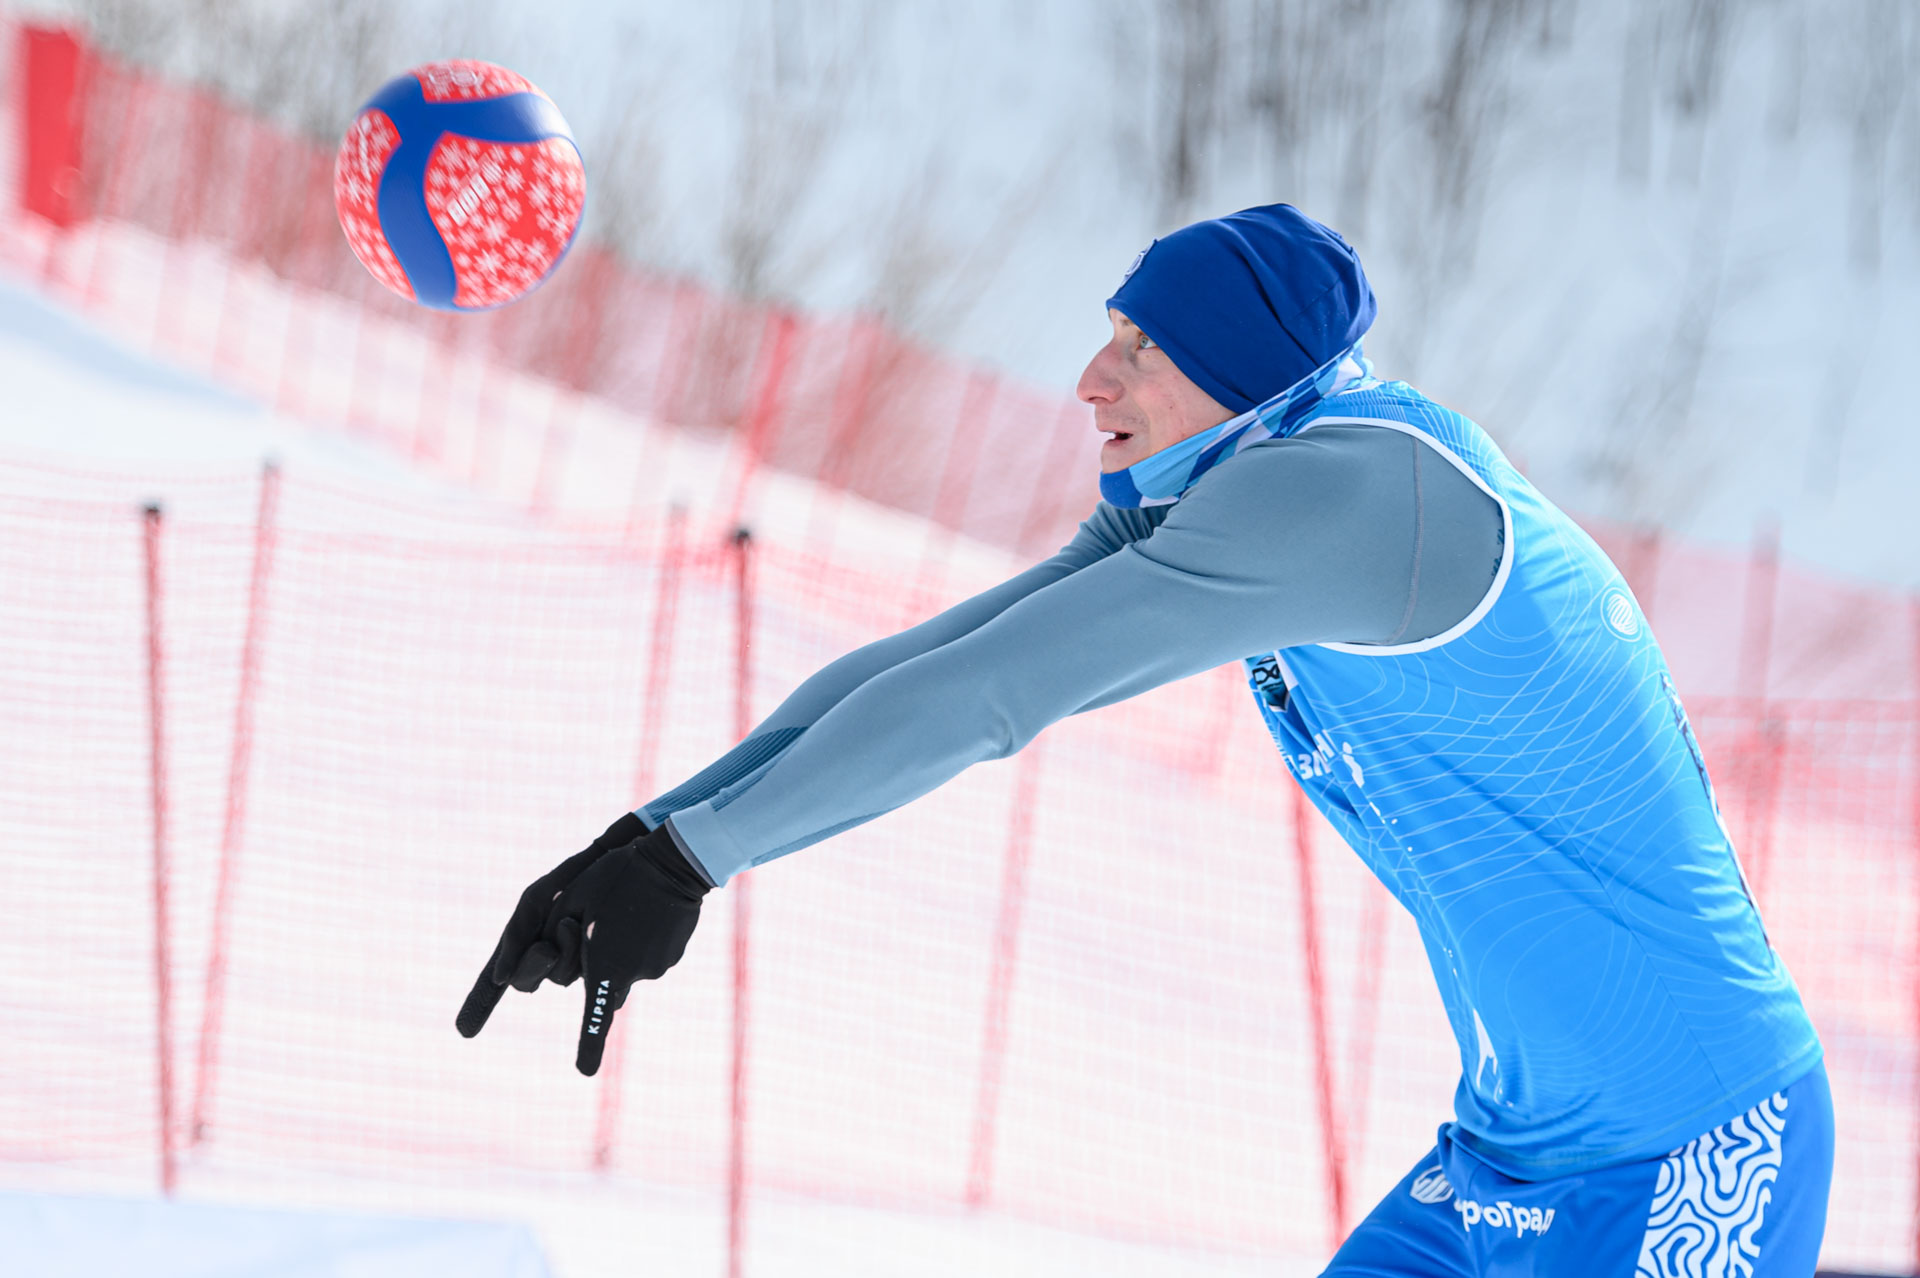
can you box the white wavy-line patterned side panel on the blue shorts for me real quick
[1634,1092,1788,1278]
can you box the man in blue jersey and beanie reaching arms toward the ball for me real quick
[459,205,1834,1278]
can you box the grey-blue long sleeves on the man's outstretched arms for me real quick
[639,424,1503,885]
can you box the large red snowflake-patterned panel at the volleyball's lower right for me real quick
[426,134,586,307]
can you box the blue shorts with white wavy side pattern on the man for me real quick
[1325,1065,1834,1278]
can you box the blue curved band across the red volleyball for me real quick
[361,75,574,311]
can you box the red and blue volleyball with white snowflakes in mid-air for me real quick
[334,59,588,311]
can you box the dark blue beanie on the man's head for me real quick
[1106,203,1373,414]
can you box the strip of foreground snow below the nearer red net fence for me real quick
[0,1171,1319,1278]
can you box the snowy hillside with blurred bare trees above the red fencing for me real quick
[11,0,1920,583]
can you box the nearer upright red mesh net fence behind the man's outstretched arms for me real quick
[11,452,1920,1265]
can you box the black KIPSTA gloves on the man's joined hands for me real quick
[455,816,710,1075]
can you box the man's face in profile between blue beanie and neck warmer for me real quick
[1073,309,1233,474]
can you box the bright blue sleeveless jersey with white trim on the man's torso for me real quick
[1246,382,1820,1180]
